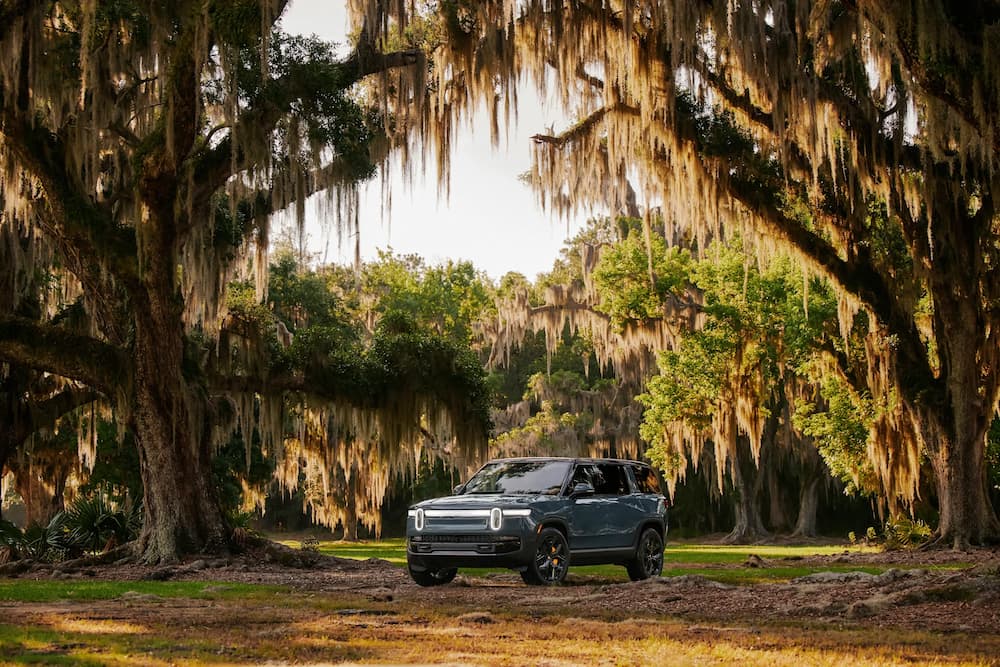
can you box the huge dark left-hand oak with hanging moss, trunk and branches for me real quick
[0,0,485,562]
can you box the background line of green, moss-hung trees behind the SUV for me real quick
[8,218,1000,552]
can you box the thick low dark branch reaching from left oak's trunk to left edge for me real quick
[0,316,128,396]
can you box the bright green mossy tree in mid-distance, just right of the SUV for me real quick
[640,242,833,541]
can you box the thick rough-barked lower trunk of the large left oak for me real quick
[131,303,228,563]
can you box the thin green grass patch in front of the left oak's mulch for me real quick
[0,579,288,602]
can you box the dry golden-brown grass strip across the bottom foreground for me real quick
[0,584,1000,667]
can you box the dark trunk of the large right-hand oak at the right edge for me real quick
[901,180,1000,549]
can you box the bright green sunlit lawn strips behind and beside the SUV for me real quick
[282,538,964,585]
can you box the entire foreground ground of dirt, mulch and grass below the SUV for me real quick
[0,543,1000,665]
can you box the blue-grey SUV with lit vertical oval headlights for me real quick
[406,458,667,586]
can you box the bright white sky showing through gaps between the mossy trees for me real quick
[282,0,583,279]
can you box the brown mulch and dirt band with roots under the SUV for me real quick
[7,544,1000,636]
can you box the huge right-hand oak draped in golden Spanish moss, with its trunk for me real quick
[357,0,1000,548]
